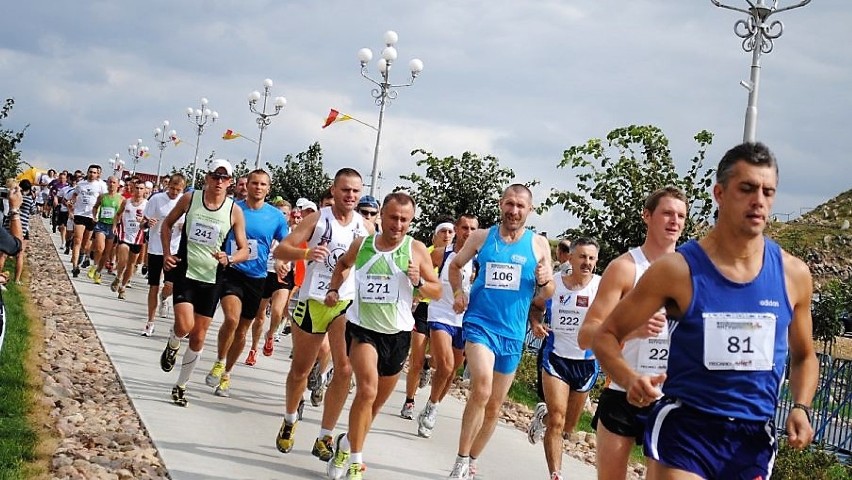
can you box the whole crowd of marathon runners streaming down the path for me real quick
[28,143,817,480]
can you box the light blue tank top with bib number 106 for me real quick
[464,226,538,342]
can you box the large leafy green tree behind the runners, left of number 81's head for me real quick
[541,125,713,268]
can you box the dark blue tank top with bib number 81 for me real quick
[663,238,793,421]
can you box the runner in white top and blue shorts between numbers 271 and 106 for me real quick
[417,214,479,438]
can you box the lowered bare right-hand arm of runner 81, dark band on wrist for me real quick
[784,252,819,450]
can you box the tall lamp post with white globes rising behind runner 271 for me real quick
[358,30,423,196]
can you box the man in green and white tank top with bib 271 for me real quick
[325,192,441,480]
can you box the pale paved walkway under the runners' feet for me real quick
[48,219,595,480]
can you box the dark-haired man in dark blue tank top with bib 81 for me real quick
[594,143,818,479]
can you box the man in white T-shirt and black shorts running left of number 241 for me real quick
[142,173,186,337]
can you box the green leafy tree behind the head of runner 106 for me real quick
[394,149,538,245]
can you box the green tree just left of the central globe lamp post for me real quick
[266,142,332,204]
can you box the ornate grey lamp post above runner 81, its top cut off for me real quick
[710,0,811,143]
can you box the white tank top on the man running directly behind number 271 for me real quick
[299,207,367,302]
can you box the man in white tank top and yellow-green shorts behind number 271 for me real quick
[275,168,373,461]
